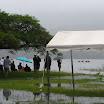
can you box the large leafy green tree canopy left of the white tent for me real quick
[0,11,52,50]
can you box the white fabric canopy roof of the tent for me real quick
[46,30,104,51]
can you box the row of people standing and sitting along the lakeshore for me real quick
[0,54,62,77]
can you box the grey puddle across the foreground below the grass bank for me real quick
[0,89,104,104]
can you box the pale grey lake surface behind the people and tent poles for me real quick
[12,59,104,74]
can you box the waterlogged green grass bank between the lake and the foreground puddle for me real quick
[0,71,104,97]
